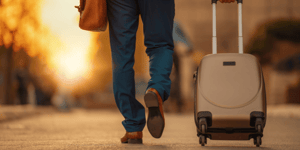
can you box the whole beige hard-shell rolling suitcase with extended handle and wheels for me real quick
[194,0,266,147]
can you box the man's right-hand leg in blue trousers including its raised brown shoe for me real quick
[138,0,175,138]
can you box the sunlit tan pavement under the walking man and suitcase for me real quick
[0,105,300,150]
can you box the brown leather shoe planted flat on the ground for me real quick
[121,131,143,144]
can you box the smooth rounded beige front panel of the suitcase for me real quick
[198,54,261,108]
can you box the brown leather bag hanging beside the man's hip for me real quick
[75,0,107,32]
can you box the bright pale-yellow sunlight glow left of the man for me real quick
[42,0,93,86]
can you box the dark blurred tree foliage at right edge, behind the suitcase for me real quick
[246,19,300,65]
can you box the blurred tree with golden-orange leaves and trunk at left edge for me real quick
[0,0,41,104]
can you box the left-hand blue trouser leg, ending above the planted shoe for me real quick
[107,0,146,132]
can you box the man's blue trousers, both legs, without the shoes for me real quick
[107,0,175,132]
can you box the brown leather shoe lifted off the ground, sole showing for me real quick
[144,88,165,138]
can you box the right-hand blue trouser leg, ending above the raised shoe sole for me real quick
[138,0,175,101]
